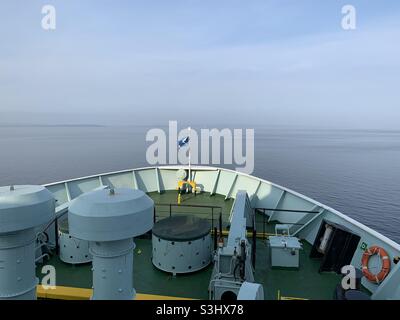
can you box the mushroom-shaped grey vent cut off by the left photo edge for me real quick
[0,185,55,300]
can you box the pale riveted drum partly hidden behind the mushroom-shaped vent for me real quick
[58,219,92,264]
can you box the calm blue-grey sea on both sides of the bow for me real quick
[0,126,400,243]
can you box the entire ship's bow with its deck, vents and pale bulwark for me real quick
[0,167,400,300]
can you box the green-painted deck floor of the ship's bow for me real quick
[37,191,346,300]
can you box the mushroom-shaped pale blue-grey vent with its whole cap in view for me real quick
[68,188,154,300]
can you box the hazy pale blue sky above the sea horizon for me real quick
[0,0,400,129]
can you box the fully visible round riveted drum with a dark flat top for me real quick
[152,215,211,274]
